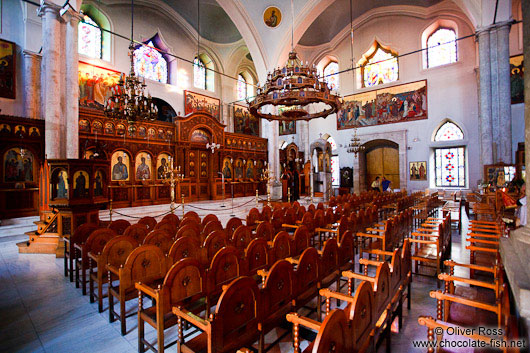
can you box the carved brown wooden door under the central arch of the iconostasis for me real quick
[189,149,211,200]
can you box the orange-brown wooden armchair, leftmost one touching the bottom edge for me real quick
[135,258,205,353]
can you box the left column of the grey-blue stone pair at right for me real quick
[478,29,493,165]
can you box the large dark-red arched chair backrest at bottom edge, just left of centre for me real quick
[211,276,261,352]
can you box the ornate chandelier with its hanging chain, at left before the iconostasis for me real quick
[104,0,158,123]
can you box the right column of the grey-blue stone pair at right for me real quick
[493,23,513,163]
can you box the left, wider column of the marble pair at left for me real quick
[39,4,63,158]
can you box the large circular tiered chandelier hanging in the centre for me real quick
[248,50,341,121]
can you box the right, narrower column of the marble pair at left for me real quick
[65,10,81,159]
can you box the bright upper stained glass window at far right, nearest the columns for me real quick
[426,28,457,67]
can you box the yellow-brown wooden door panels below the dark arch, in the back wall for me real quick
[366,147,399,190]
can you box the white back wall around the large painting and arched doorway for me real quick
[304,15,481,190]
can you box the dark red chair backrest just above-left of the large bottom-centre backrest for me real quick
[206,246,241,295]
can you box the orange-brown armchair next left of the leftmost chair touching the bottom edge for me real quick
[107,245,168,336]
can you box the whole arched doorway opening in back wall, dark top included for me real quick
[364,140,400,190]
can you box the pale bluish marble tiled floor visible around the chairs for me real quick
[0,199,467,352]
